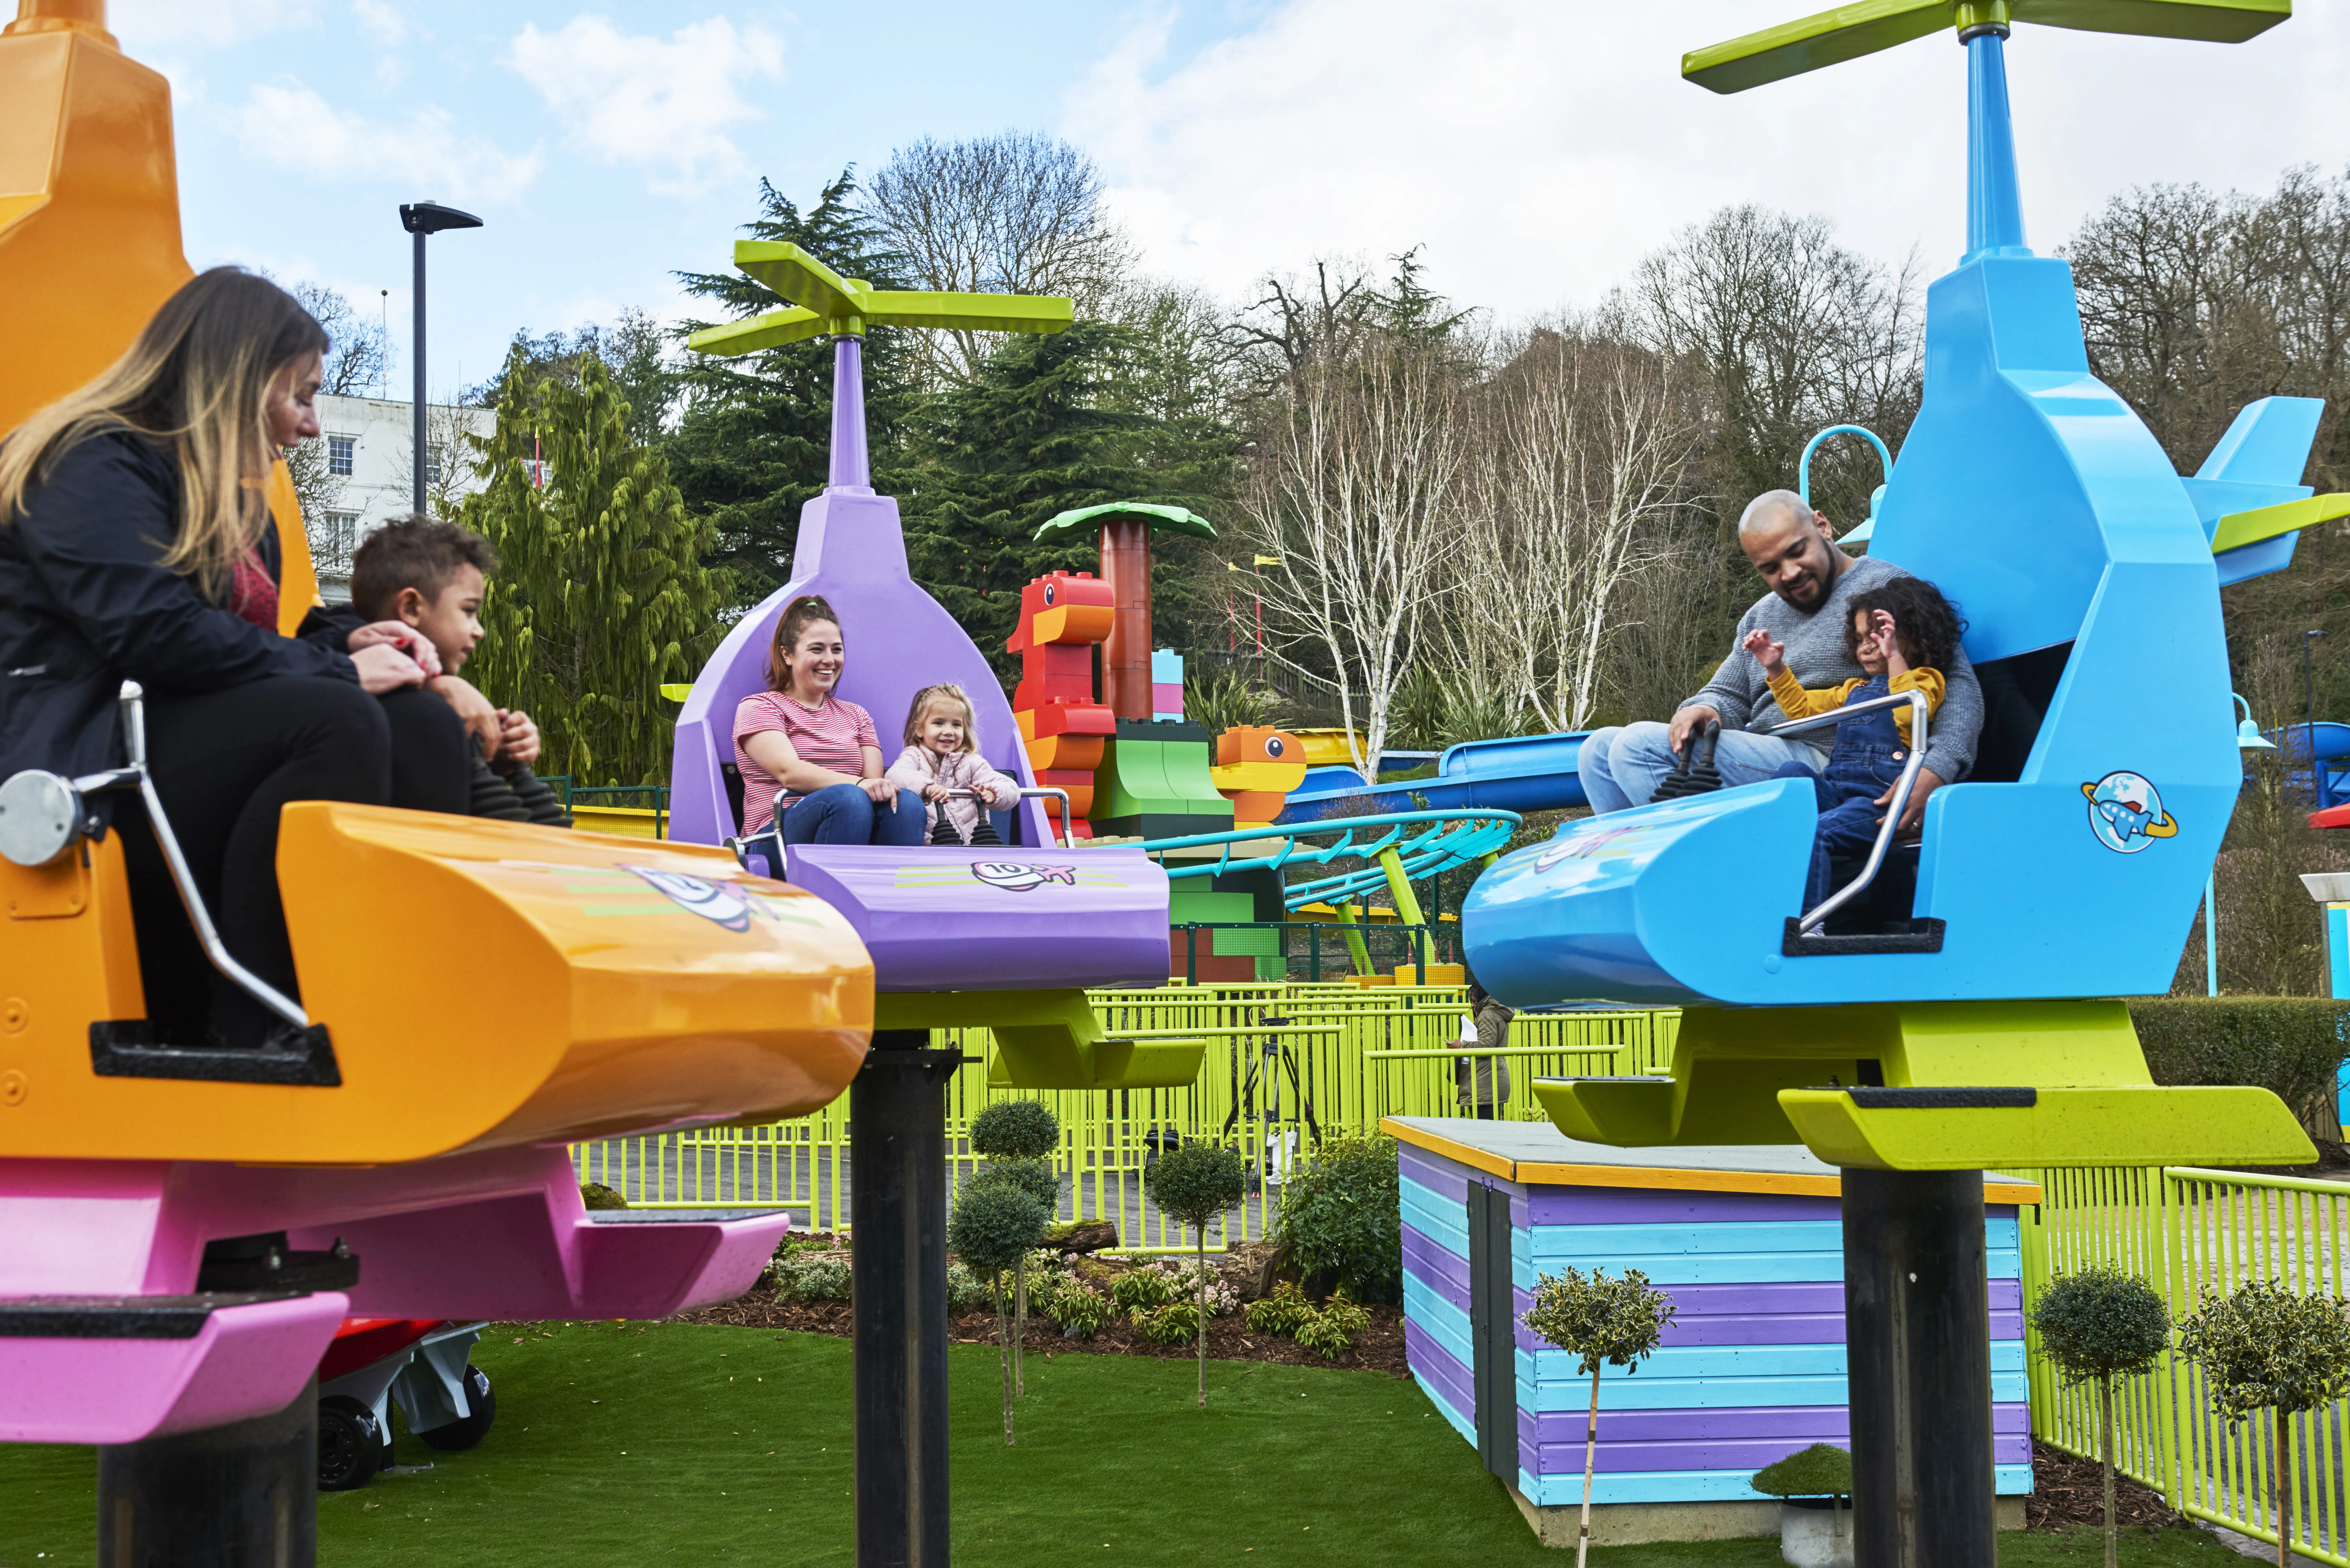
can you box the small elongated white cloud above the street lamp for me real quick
[237,80,541,200]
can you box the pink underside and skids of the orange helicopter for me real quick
[0,1147,790,1443]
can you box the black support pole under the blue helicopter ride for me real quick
[1842,1168,1998,1568]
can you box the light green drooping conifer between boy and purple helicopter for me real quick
[458,348,724,785]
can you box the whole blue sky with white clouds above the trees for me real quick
[110,0,2350,395]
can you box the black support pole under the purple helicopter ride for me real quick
[848,1030,964,1568]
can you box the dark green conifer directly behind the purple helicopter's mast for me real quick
[670,169,916,604]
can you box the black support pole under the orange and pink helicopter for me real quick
[99,1378,317,1568]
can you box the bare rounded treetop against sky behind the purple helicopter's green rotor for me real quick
[863,132,1133,381]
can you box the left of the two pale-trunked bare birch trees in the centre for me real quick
[1241,336,1464,778]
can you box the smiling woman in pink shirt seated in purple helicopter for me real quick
[736,592,924,844]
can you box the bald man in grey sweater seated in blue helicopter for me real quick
[1581,489,1984,837]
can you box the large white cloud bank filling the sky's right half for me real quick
[1064,0,2350,315]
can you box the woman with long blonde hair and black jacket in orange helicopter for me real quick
[0,268,465,1048]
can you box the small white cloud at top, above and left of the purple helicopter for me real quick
[508,16,783,195]
